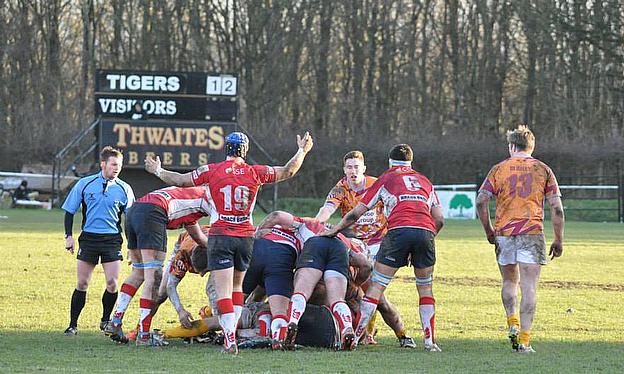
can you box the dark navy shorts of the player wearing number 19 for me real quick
[208,235,253,271]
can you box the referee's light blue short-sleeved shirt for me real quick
[63,172,134,234]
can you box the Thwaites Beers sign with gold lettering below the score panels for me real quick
[99,119,235,170]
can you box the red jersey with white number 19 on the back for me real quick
[192,159,275,237]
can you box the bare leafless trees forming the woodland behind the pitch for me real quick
[0,0,624,196]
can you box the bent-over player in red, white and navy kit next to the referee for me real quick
[104,187,210,346]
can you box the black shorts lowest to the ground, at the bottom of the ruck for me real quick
[295,304,338,348]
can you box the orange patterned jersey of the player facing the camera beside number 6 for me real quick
[325,175,386,244]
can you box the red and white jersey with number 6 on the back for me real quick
[360,166,440,233]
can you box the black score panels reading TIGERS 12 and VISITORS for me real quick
[95,70,238,122]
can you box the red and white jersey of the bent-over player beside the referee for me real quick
[135,186,211,230]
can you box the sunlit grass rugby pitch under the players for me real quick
[0,210,624,373]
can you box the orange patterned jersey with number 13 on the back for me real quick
[479,157,561,236]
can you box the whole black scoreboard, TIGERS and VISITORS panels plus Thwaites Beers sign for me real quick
[95,70,239,170]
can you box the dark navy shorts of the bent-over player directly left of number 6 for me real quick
[297,236,349,279]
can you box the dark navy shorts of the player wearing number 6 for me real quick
[376,228,435,269]
